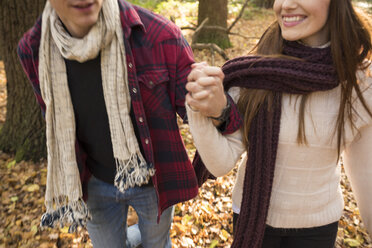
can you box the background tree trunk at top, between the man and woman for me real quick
[196,0,231,48]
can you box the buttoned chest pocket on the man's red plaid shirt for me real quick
[138,70,174,116]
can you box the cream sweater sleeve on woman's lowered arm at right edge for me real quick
[344,124,372,237]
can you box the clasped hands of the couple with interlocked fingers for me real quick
[186,62,227,122]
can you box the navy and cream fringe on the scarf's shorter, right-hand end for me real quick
[114,154,155,193]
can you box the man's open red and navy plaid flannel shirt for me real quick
[18,0,239,217]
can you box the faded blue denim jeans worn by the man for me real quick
[87,176,173,248]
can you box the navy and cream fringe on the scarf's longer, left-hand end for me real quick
[40,197,92,233]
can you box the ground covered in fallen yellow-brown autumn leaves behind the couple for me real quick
[0,1,372,248]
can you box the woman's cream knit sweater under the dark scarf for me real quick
[186,66,372,235]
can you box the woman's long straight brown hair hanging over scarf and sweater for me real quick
[238,0,372,155]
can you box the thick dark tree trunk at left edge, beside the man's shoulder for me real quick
[0,0,46,161]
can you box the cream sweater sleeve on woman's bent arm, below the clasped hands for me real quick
[186,88,245,177]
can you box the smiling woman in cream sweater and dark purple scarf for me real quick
[186,0,372,248]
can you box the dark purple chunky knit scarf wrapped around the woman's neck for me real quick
[223,41,339,248]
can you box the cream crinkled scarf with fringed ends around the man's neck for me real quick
[39,0,155,231]
